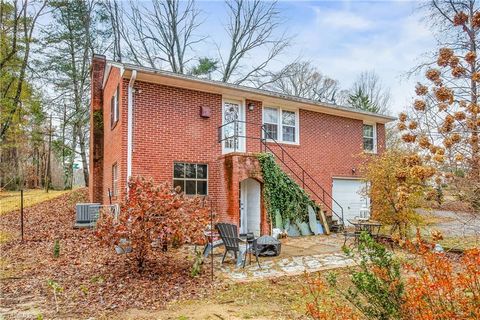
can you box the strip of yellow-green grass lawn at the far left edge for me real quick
[0,189,71,215]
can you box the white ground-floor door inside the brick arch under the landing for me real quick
[240,178,261,237]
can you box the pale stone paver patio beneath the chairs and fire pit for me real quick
[210,234,354,282]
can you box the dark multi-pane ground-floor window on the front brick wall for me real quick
[173,162,208,196]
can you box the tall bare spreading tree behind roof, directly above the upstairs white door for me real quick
[220,0,289,84]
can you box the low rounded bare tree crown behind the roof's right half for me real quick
[260,61,348,104]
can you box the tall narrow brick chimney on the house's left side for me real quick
[88,54,106,203]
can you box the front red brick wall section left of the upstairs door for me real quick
[132,82,227,213]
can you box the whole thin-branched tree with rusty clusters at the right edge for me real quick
[398,0,480,211]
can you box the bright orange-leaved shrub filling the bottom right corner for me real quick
[403,242,480,320]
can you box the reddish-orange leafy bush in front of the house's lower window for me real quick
[96,177,210,272]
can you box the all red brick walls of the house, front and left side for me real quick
[92,73,385,232]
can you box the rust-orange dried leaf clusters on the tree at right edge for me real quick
[398,12,480,172]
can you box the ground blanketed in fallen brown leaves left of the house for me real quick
[0,189,211,318]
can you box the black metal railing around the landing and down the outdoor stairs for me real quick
[218,120,344,228]
